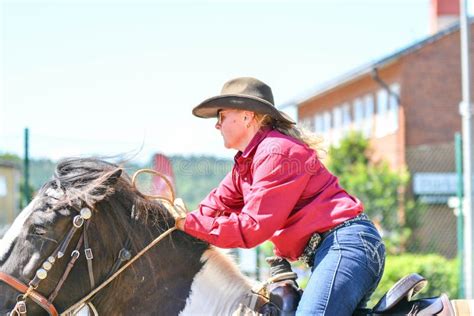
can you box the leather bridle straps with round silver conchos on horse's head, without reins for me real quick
[0,208,92,316]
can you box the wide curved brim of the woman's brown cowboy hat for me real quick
[193,94,296,124]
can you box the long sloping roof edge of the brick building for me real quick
[286,18,474,108]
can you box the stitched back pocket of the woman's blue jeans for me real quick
[359,232,385,279]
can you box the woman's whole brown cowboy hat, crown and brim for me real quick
[193,77,296,124]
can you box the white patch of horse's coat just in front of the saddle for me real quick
[182,247,252,315]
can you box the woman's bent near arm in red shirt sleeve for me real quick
[184,154,310,248]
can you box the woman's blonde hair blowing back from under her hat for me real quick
[255,113,325,156]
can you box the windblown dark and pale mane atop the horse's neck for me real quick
[38,157,174,230]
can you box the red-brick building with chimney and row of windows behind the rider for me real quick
[296,0,474,257]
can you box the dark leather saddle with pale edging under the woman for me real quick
[259,258,455,316]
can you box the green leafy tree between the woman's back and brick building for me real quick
[327,133,416,253]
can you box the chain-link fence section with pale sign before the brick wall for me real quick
[406,142,458,259]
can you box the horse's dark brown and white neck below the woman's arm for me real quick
[88,211,251,315]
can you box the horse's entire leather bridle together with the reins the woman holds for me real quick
[0,169,181,316]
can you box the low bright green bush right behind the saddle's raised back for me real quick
[369,254,459,307]
